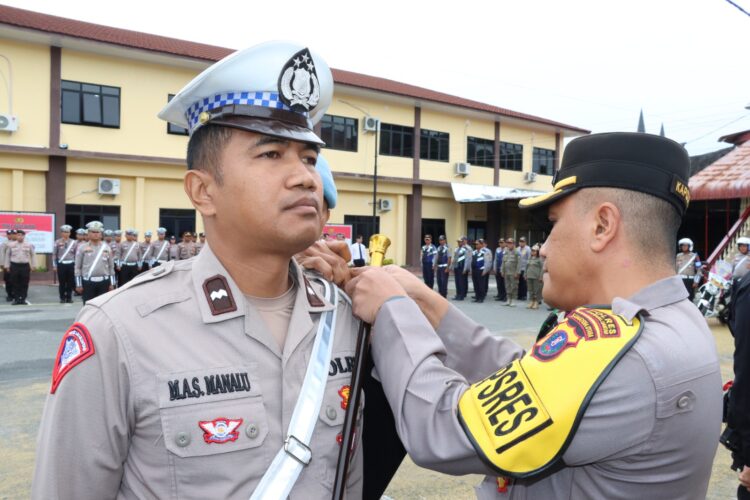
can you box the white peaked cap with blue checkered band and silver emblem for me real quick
[159,41,333,145]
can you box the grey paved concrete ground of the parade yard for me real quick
[0,285,737,500]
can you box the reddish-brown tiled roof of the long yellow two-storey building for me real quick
[0,5,590,134]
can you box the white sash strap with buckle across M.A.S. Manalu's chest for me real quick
[250,280,338,500]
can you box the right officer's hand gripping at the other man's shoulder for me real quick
[346,267,407,323]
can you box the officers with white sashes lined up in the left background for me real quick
[0,221,205,305]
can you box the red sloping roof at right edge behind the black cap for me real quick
[690,140,750,200]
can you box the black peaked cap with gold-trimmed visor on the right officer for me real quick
[518,132,690,216]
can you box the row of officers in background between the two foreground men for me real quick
[421,234,543,309]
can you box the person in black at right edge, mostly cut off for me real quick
[722,279,750,500]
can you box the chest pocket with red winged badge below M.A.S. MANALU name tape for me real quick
[158,367,275,484]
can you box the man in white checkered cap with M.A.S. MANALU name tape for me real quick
[32,42,363,500]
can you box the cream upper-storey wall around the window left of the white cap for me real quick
[60,49,197,158]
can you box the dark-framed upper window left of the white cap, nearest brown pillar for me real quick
[60,80,120,128]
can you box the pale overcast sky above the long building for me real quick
[5,0,750,154]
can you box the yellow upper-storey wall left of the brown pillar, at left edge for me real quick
[0,39,50,147]
